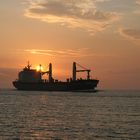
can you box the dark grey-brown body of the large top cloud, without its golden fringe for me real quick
[28,1,115,21]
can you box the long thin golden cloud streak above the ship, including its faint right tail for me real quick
[25,48,118,59]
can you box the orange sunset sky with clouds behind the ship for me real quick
[0,0,140,90]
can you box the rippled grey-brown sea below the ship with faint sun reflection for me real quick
[0,89,140,140]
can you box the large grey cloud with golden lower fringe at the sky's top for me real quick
[25,0,119,33]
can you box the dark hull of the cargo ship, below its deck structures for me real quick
[13,80,99,91]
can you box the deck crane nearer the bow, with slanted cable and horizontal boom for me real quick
[72,62,91,81]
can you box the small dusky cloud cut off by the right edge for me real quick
[119,29,140,41]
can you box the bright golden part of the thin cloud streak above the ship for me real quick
[25,48,93,57]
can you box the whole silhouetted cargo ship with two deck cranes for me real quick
[13,62,99,91]
